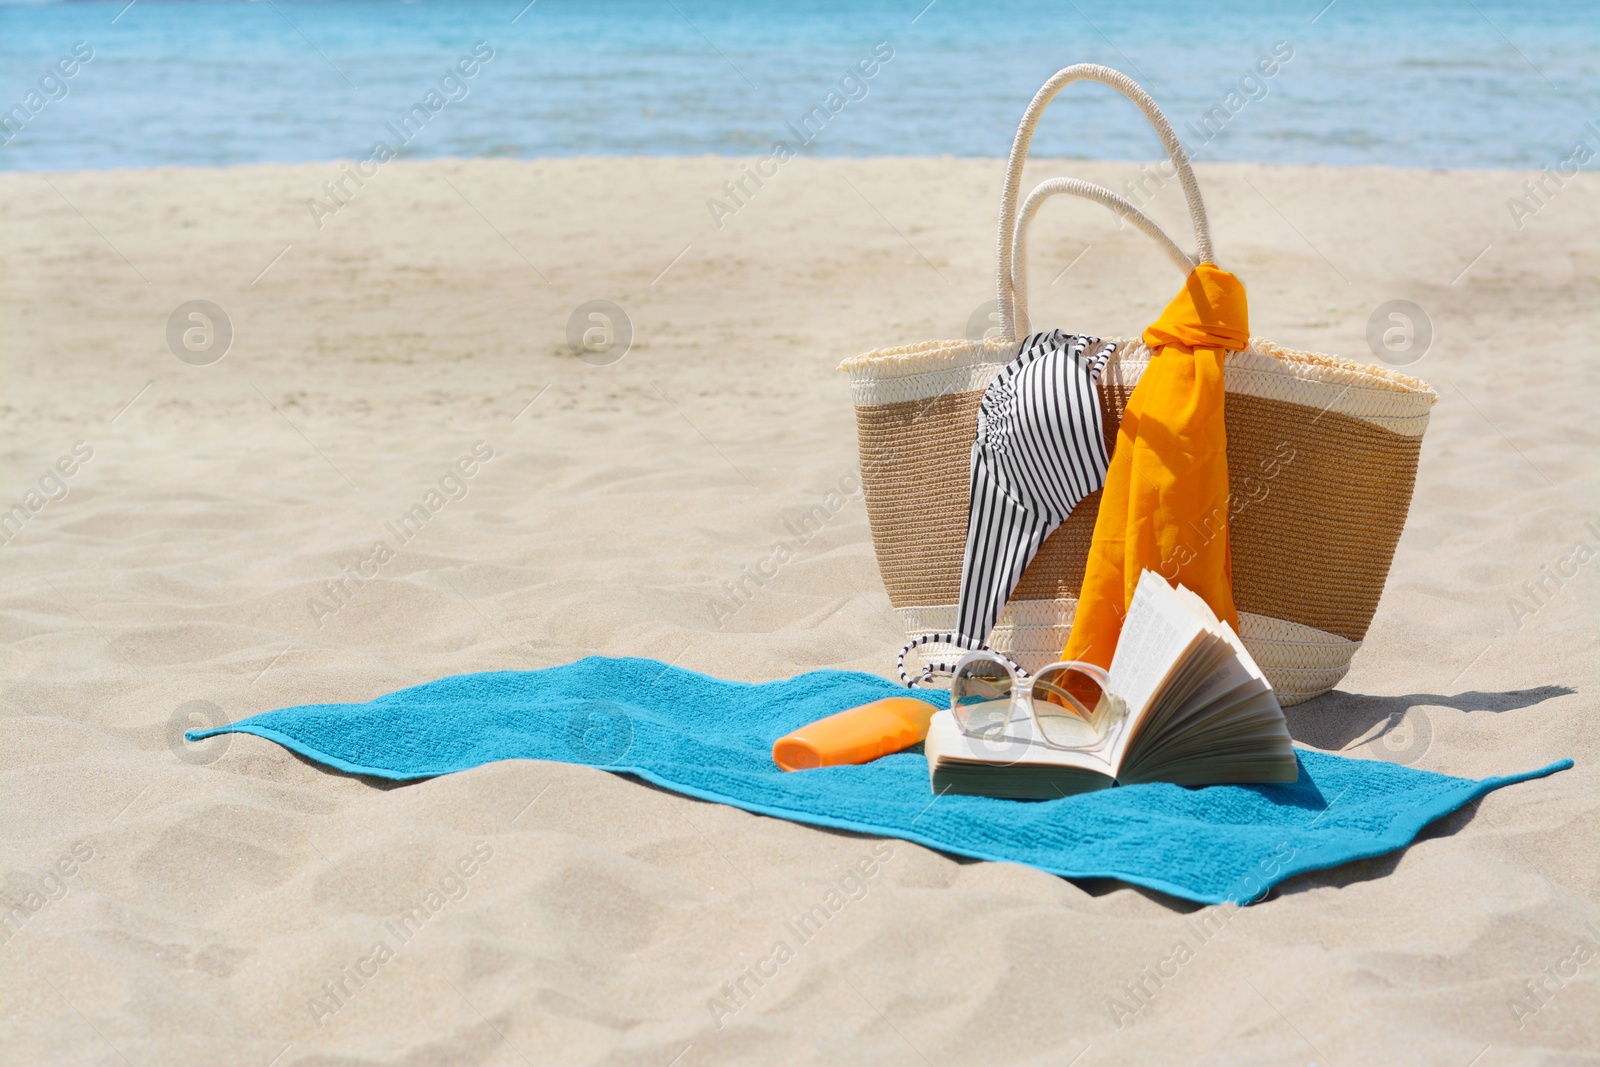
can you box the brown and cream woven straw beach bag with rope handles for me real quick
[842,64,1438,704]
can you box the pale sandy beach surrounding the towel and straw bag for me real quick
[0,157,1600,1067]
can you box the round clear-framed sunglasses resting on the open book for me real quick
[950,651,1128,750]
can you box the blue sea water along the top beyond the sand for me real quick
[0,0,1600,170]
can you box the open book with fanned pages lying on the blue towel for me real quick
[925,571,1299,800]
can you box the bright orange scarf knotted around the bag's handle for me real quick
[1061,262,1250,667]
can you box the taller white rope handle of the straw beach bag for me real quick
[995,62,1213,341]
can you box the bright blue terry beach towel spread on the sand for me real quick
[187,656,1573,904]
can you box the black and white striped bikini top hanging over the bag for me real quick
[899,330,1117,685]
